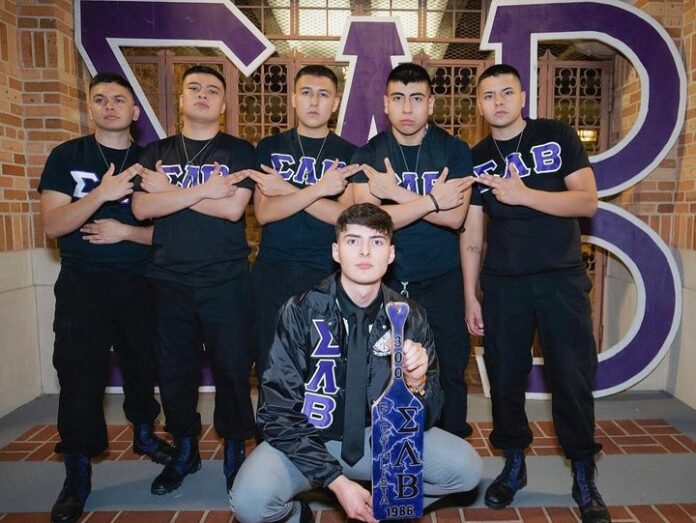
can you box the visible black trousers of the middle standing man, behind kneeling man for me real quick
[251,259,331,382]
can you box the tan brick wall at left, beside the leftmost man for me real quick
[0,0,86,251]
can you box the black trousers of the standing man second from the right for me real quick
[387,268,472,438]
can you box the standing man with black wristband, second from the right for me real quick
[353,63,474,438]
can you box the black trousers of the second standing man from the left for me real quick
[152,271,255,440]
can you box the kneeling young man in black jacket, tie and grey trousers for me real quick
[230,203,482,523]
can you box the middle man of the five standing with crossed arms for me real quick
[251,65,358,383]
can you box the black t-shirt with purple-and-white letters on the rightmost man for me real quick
[471,119,591,276]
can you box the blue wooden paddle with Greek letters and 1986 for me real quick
[372,302,424,520]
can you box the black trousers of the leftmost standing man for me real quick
[53,267,160,456]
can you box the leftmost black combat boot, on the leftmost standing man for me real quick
[51,452,92,523]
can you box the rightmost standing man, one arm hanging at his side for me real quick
[460,65,610,523]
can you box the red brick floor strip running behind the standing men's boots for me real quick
[0,419,696,461]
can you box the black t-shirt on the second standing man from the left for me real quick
[141,133,255,287]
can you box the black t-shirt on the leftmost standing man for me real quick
[39,135,150,275]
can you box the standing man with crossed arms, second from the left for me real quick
[133,66,255,494]
